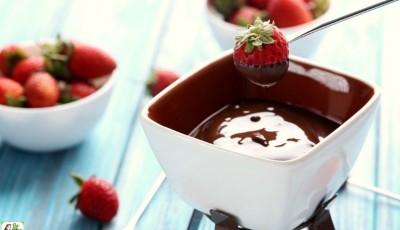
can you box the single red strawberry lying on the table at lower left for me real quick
[70,174,118,222]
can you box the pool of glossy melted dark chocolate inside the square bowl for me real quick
[190,100,339,160]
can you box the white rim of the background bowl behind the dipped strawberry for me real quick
[206,0,334,35]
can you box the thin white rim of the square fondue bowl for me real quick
[140,49,381,165]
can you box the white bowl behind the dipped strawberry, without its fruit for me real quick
[205,0,334,57]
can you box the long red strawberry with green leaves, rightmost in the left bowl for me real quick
[42,38,117,80]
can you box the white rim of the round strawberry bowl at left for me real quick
[0,39,116,113]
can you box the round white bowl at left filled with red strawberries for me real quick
[0,39,117,153]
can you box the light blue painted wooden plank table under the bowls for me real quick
[0,0,400,230]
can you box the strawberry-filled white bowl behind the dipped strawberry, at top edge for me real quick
[206,0,332,57]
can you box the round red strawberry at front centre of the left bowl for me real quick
[25,72,60,108]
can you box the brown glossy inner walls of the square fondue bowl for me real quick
[148,54,374,142]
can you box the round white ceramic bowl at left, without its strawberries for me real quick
[0,44,116,153]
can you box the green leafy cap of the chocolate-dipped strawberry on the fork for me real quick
[235,17,274,53]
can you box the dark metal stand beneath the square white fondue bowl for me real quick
[209,195,337,230]
